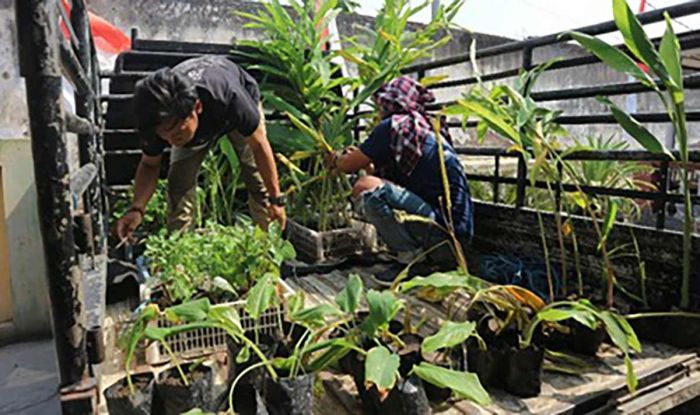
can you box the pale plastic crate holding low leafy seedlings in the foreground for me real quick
[146,280,294,365]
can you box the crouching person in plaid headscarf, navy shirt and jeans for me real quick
[332,76,473,279]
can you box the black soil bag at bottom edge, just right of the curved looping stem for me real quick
[265,373,316,415]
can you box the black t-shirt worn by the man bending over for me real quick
[142,56,260,156]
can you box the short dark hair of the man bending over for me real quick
[134,68,197,136]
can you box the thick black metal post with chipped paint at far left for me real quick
[15,0,87,387]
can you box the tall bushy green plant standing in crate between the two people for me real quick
[236,0,381,231]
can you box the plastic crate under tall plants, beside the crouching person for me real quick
[287,220,377,262]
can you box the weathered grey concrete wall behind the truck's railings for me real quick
[88,0,700,150]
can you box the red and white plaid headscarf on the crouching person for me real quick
[374,76,452,176]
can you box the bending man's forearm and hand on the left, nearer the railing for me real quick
[116,154,162,240]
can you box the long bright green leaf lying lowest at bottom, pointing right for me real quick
[413,362,491,406]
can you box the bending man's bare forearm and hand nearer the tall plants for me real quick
[245,121,287,226]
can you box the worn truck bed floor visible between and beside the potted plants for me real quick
[287,265,700,415]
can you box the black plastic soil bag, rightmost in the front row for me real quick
[505,345,544,398]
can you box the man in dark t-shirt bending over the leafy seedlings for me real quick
[116,56,286,240]
